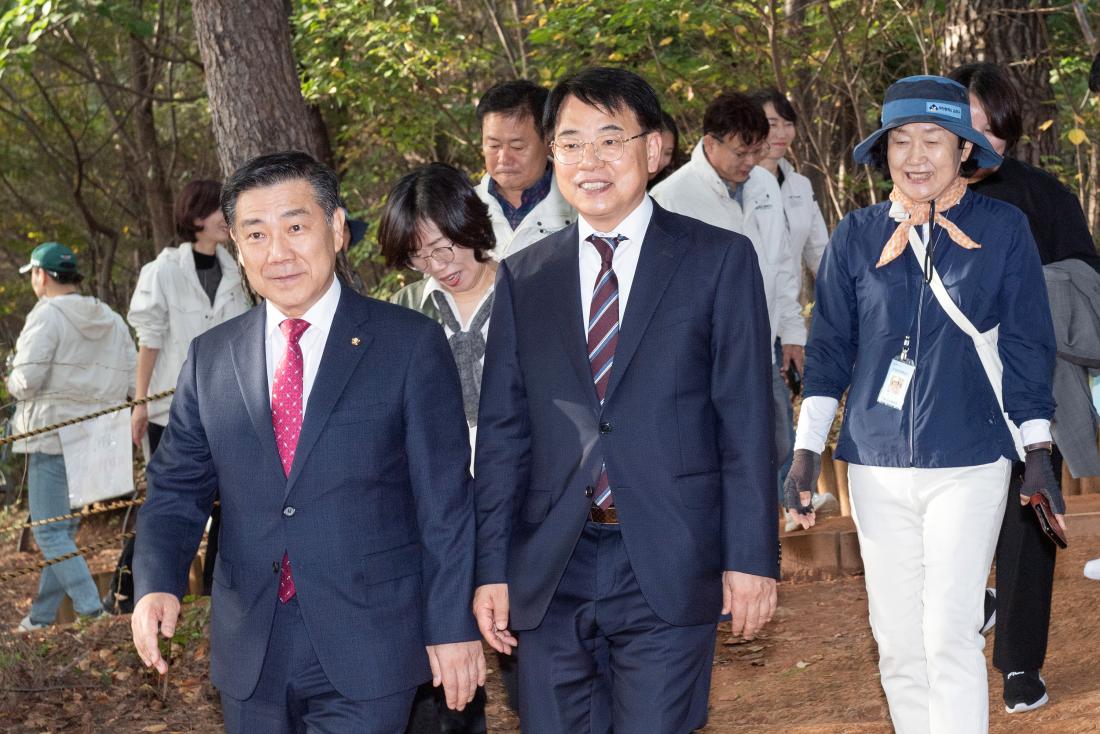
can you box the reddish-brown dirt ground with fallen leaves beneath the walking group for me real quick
[0,510,1100,734]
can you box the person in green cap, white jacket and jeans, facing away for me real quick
[8,242,136,632]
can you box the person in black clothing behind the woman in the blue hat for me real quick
[948,63,1100,713]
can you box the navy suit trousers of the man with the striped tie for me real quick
[518,523,717,734]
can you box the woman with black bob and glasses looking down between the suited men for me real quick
[378,163,497,734]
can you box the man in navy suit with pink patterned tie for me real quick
[132,153,485,734]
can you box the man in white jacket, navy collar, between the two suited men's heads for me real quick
[476,79,576,260]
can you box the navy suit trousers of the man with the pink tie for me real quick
[221,599,416,734]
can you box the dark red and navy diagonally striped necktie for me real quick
[589,234,626,510]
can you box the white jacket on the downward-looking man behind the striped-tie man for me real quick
[650,141,806,357]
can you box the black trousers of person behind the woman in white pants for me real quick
[993,448,1062,673]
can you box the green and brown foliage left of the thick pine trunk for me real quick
[0,0,217,330]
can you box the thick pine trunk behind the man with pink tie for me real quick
[191,0,329,177]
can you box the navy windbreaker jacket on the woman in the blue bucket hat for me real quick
[804,190,1055,468]
